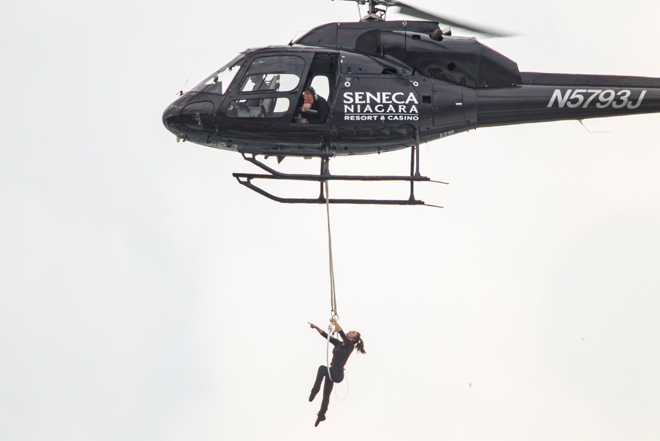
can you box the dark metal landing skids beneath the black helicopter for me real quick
[233,139,446,208]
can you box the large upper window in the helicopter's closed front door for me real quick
[239,56,305,93]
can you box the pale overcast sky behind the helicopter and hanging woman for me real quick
[0,0,660,441]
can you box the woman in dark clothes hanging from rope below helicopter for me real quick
[309,318,366,427]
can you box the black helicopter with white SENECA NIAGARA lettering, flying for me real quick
[163,0,660,205]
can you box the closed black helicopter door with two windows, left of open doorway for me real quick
[223,53,311,122]
